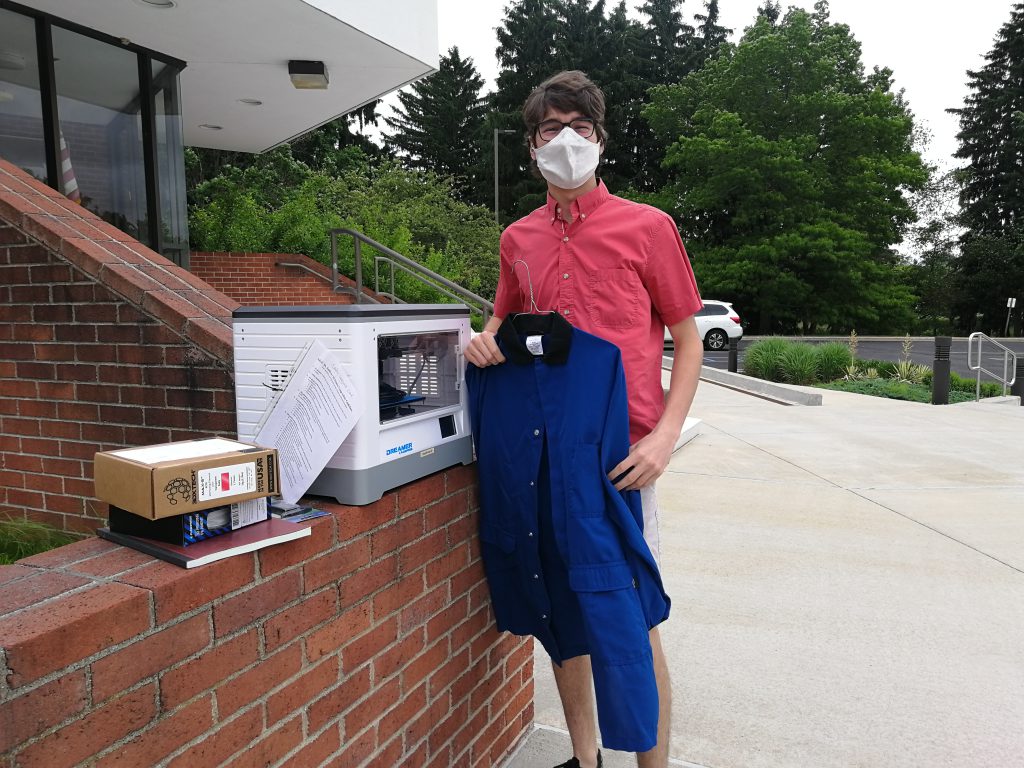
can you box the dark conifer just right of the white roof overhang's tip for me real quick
[384,47,486,198]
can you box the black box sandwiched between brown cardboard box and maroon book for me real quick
[110,497,270,547]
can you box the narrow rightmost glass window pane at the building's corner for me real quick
[153,61,188,265]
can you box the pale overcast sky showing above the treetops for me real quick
[437,0,1013,167]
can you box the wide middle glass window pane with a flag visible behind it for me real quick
[52,26,150,243]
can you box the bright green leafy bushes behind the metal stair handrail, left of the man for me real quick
[189,146,499,309]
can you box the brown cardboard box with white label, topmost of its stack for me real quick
[93,437,281,520]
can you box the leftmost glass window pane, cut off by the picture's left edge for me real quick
[0,8,46,181]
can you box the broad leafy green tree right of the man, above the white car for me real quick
[644,2,928,333]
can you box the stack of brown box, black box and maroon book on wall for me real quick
[94,438,309,568]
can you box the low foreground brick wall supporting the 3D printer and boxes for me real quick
[0,467,534,768]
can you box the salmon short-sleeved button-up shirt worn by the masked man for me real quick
[495,182,702,442]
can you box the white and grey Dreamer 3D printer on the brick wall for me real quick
[232,304,473,504]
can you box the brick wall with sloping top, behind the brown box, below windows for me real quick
[0,161,238,532]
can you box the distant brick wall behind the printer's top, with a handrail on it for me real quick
[188,251,369,306]
